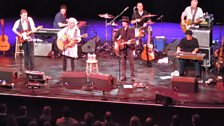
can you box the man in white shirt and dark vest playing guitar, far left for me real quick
[12,9,37,70]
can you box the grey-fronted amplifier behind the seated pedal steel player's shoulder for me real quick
[190,28,212,47]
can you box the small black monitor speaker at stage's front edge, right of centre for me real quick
[155,94,173,106]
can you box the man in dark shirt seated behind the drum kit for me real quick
[131,2,151,44]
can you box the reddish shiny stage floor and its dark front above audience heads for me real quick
[0,51,224,126]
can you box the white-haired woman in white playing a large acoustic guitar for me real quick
[58,18,81,71]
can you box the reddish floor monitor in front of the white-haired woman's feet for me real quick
[61,71,87,87]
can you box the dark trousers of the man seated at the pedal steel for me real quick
[179,59,200,77]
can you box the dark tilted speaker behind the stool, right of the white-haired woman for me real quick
[82,40,96,53]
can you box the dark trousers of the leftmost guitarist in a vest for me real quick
[22,42,34,70]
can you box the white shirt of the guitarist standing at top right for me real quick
[182,6,203,21]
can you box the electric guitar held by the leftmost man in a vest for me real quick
[17,26,43,43]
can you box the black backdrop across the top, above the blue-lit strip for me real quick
[0,0,224,22]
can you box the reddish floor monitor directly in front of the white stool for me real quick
[89,73,117,91]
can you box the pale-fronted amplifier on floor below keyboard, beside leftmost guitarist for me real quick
[34,42,52,56]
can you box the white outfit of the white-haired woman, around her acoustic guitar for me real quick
[58,27,81,58]
